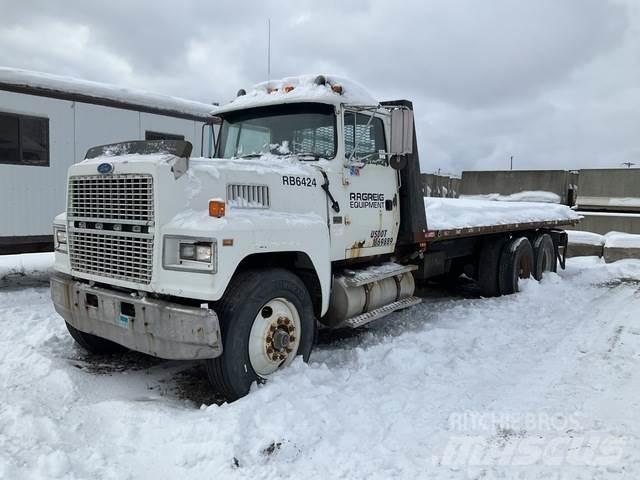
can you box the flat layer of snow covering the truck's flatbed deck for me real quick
[424,197,582,230]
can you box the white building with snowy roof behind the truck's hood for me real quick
[0,67,214,254]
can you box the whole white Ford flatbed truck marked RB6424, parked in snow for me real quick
[51,76,579,400]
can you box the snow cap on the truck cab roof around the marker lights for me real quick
[213,75,379,115]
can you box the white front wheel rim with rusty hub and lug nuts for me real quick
[249,297,302,377]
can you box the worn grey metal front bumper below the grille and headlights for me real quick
[51,275,222,360]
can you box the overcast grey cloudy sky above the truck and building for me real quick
[0,0,640,173]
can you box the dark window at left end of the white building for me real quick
[0,113,49,167]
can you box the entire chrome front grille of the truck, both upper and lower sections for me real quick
[67,175,154,284]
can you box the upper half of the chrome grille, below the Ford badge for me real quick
[67,175,153,225]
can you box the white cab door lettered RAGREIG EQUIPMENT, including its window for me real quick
[333,109,400,259]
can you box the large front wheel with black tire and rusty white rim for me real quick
[207,269,315,401]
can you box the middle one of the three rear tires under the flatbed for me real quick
[498,237,533,295]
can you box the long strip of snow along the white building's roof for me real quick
[0,67,214,117]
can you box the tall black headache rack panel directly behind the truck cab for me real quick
[380,100,427,247]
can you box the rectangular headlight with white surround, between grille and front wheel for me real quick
[162,235,217,273]
